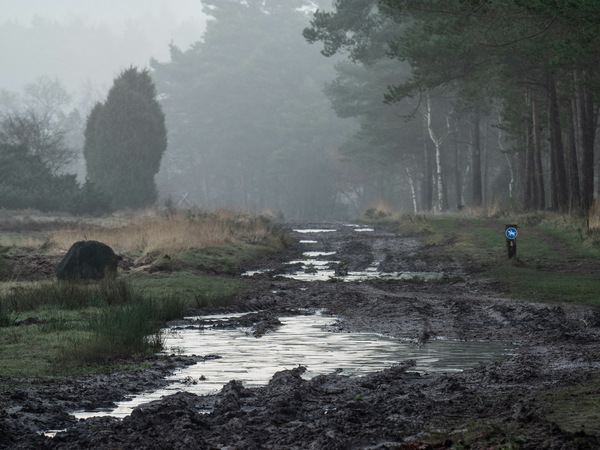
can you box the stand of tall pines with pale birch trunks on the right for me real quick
[303,0,600,214]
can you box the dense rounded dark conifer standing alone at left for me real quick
[84,67,167,209]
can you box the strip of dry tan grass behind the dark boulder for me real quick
[51,210,284,258]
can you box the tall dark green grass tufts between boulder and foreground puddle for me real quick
[0,280,188,365]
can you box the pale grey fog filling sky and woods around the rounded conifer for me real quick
[0,0,596,218]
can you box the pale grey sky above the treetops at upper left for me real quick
[0,0,206,91]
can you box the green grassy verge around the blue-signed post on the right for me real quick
[366,207,600,305]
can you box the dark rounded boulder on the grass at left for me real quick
[56,241,122,280]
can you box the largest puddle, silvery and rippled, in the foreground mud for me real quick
[74,312,512,418]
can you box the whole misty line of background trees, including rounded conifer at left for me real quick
[0,0,600,217]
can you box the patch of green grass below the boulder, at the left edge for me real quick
[0,280,188,377]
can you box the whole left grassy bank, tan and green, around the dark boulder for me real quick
[0,211,286,377]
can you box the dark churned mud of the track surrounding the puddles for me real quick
[0,223,600,449]
